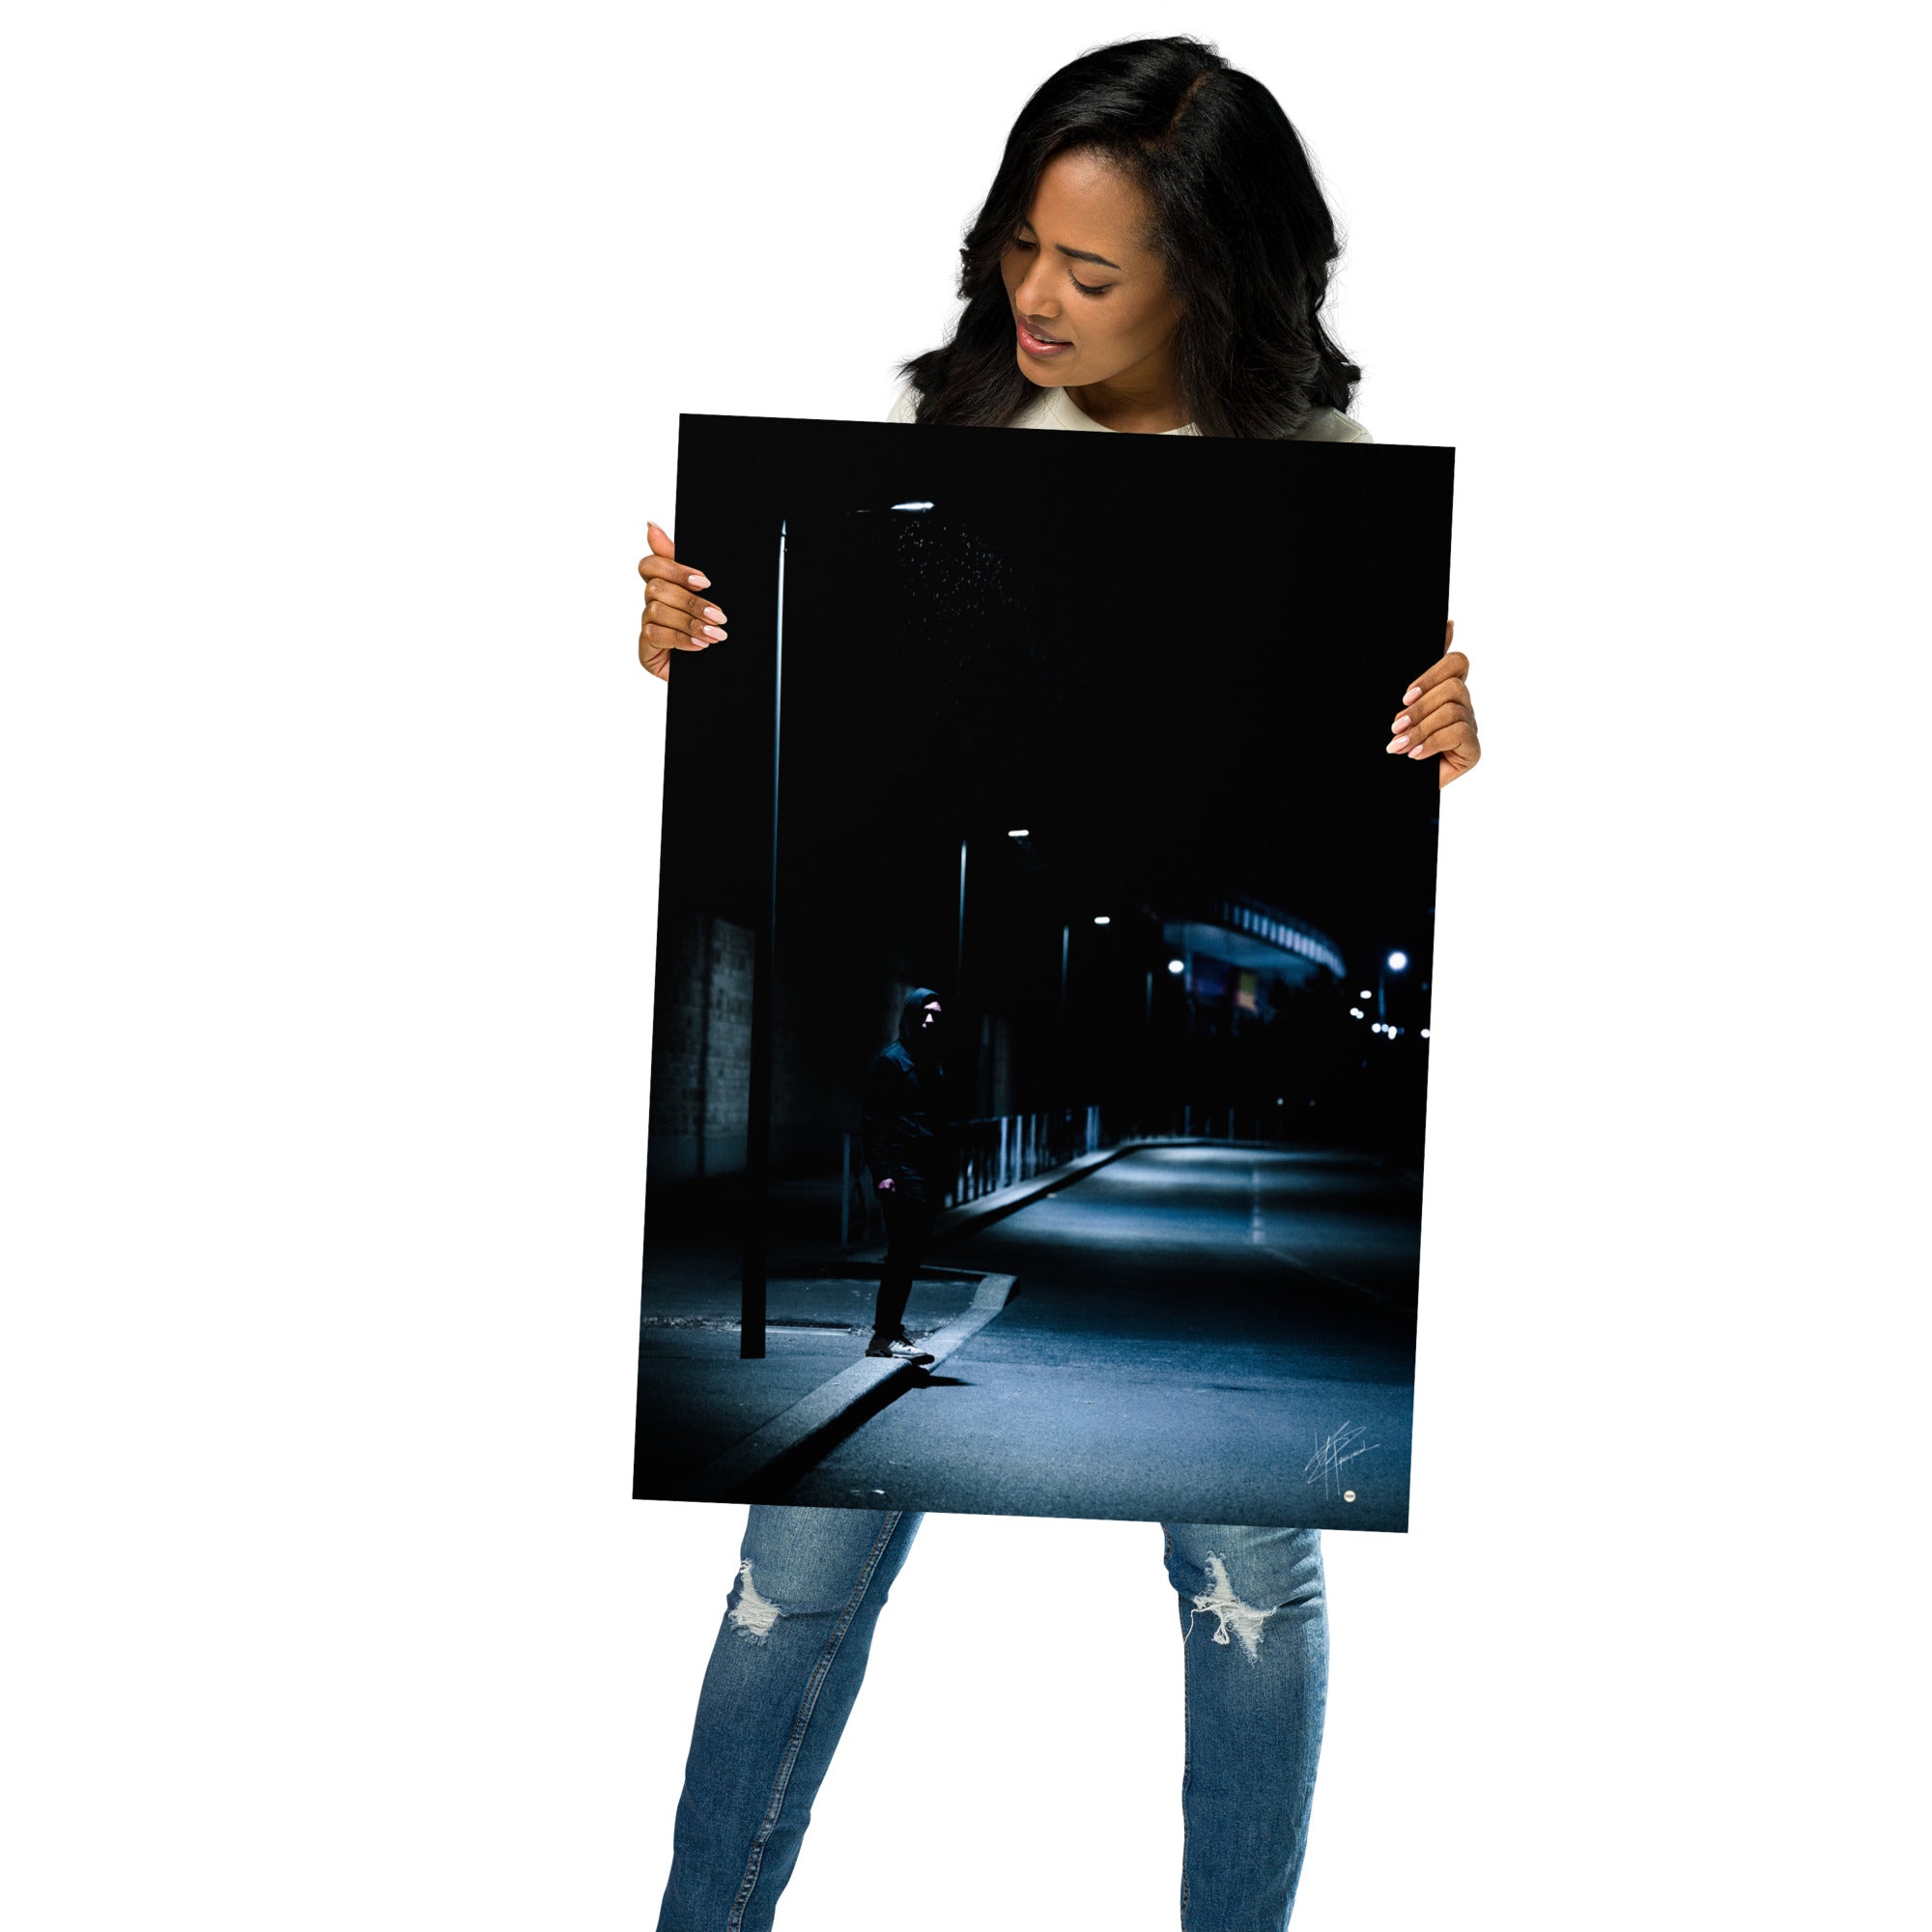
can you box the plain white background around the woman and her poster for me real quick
[0,0,1926,1932]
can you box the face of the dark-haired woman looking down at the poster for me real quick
[999,151,1180,388]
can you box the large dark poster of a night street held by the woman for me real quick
[634,415,1453,1530]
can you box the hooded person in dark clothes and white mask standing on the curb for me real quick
[864,985,958,1362]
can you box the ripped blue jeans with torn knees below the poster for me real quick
[657,1503,1327,1932]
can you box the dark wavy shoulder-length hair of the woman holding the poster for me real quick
[900,35,1362,437]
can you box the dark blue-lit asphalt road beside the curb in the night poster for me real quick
[767,1146,1422,1530]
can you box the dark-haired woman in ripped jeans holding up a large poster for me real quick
[638,39,1480,1932]
